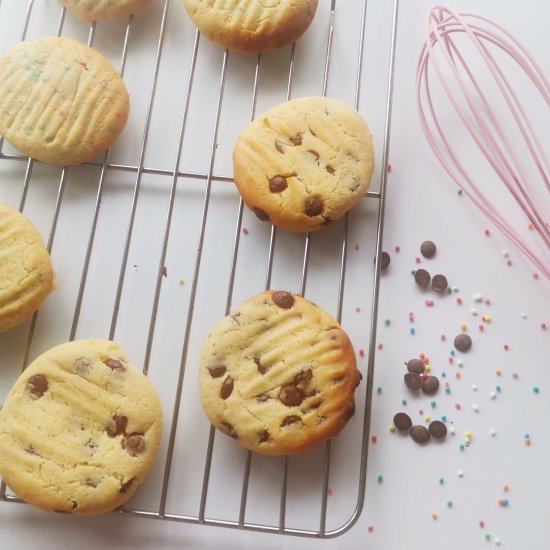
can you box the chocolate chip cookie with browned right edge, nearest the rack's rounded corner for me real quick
[199,290,360,455]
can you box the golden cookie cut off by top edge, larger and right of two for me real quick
[184,0,318,53]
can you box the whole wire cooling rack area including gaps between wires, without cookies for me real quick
[0,0,398,538]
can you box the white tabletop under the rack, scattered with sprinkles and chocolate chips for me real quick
[0,0,550,550]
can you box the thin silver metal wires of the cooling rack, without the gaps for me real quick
[0,0,398,538]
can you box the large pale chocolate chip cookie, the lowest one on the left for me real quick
[0,340,162,514]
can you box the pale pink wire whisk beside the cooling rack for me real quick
[416,5,550,279]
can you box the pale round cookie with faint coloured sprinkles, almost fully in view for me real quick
[0,37,130,166]
